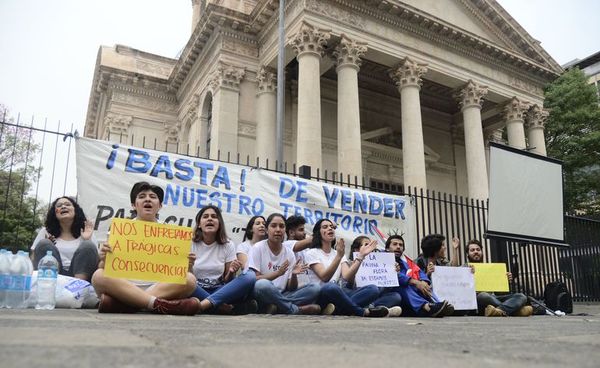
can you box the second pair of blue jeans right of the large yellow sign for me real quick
[254,279,321,314]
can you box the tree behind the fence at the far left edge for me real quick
[0,104,44,250]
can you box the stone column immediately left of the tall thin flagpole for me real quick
[256,67,277,165]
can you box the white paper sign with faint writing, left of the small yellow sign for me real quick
[431,266,477,310]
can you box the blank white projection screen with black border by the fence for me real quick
[487,143,566,246]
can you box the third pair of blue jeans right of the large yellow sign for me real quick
[319,282,379,316]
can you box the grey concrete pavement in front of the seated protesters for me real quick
[0,304,600,368]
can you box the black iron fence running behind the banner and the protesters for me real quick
[0,117,600,301]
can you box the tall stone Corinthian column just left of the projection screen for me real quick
[456,80,489,199]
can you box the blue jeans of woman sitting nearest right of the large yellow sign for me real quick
[190,271,256,308]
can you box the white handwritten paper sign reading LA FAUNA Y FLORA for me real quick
[354,252,398,287]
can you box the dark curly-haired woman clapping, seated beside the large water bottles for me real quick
[31,197,98,281]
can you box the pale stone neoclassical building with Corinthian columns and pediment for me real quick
[85,0,562,198]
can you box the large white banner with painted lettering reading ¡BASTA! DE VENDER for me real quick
[77,138,417,254]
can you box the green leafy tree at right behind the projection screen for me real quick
[544,68,600,217]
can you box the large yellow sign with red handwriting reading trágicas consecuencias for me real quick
[104,218,192,284]
